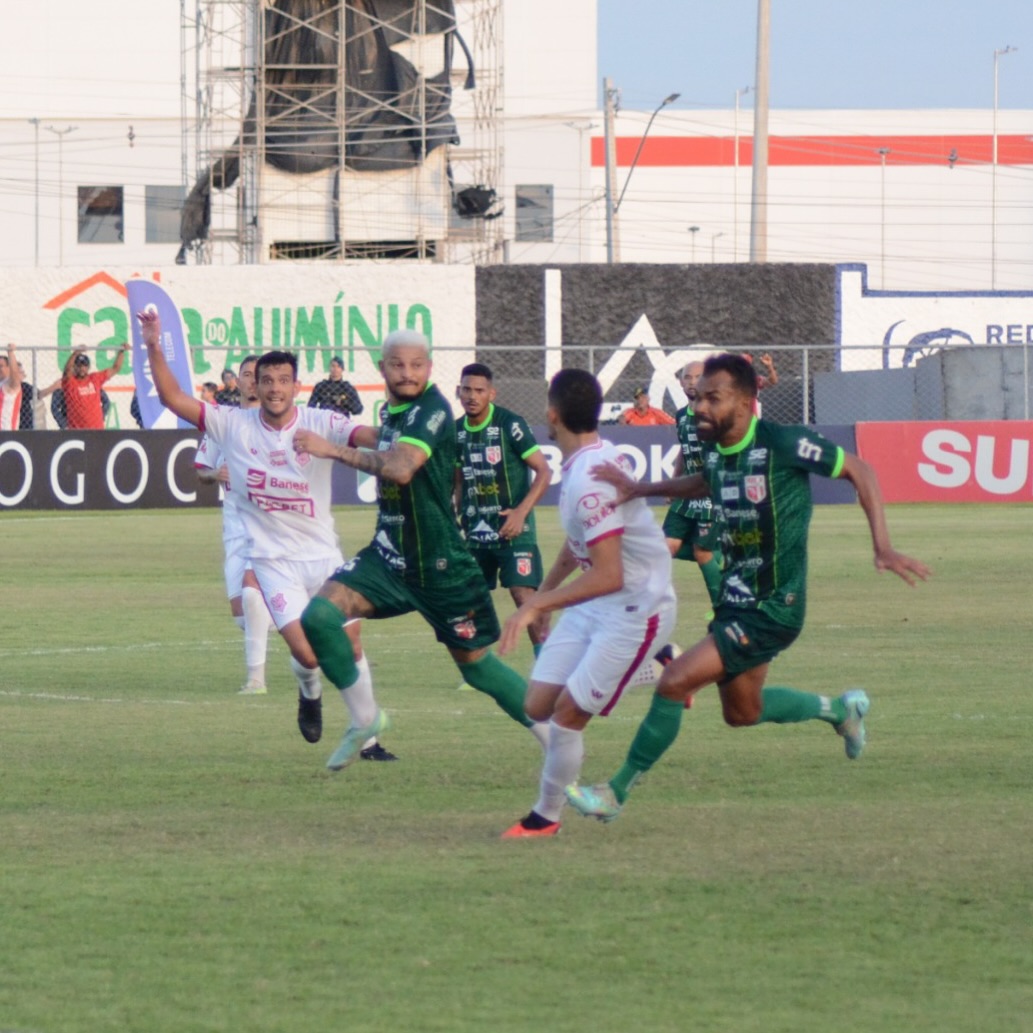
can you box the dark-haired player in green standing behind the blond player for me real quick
[456,363,553,656]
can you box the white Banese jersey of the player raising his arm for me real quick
[200,404,357,560]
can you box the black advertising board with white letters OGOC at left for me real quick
[0,431,219,510]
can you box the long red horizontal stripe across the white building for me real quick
[592,134,1033,168]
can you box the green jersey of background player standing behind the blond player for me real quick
[456,404,539,549]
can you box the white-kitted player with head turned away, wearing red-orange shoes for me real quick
[499,370,677,839]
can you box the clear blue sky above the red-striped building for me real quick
[598,0,1033,113]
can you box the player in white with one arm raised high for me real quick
[137,312,388,756]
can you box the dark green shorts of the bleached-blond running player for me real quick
[331,545,499,650]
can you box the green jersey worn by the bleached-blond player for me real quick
[373,384,471,585]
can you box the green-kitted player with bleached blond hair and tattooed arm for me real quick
[294,331,547,771]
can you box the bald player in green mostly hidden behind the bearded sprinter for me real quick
[663,363,721,606]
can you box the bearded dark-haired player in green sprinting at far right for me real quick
[566,354,930,821]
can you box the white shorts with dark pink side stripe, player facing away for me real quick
[531,602,678,717]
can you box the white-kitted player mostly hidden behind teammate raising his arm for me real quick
[194,355,276,695]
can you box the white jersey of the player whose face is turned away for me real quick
[560,439,675,614]
